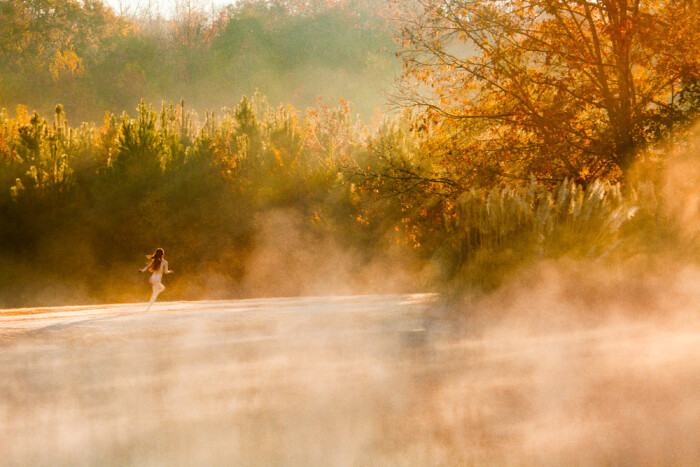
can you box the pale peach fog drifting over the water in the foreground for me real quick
[0,288,700,465]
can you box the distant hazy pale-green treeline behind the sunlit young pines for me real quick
[0,0,398,122]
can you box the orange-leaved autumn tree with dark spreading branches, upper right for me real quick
[397,0,700,186]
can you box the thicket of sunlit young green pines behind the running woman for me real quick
[0,94,388,306]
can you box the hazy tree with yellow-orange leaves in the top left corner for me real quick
[0,0,125,119]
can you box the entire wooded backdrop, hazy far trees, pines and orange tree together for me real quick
[0,0,700,306]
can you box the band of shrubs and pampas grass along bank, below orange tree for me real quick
[0,94,695,306]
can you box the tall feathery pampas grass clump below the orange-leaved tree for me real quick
[433,180,658,291]
